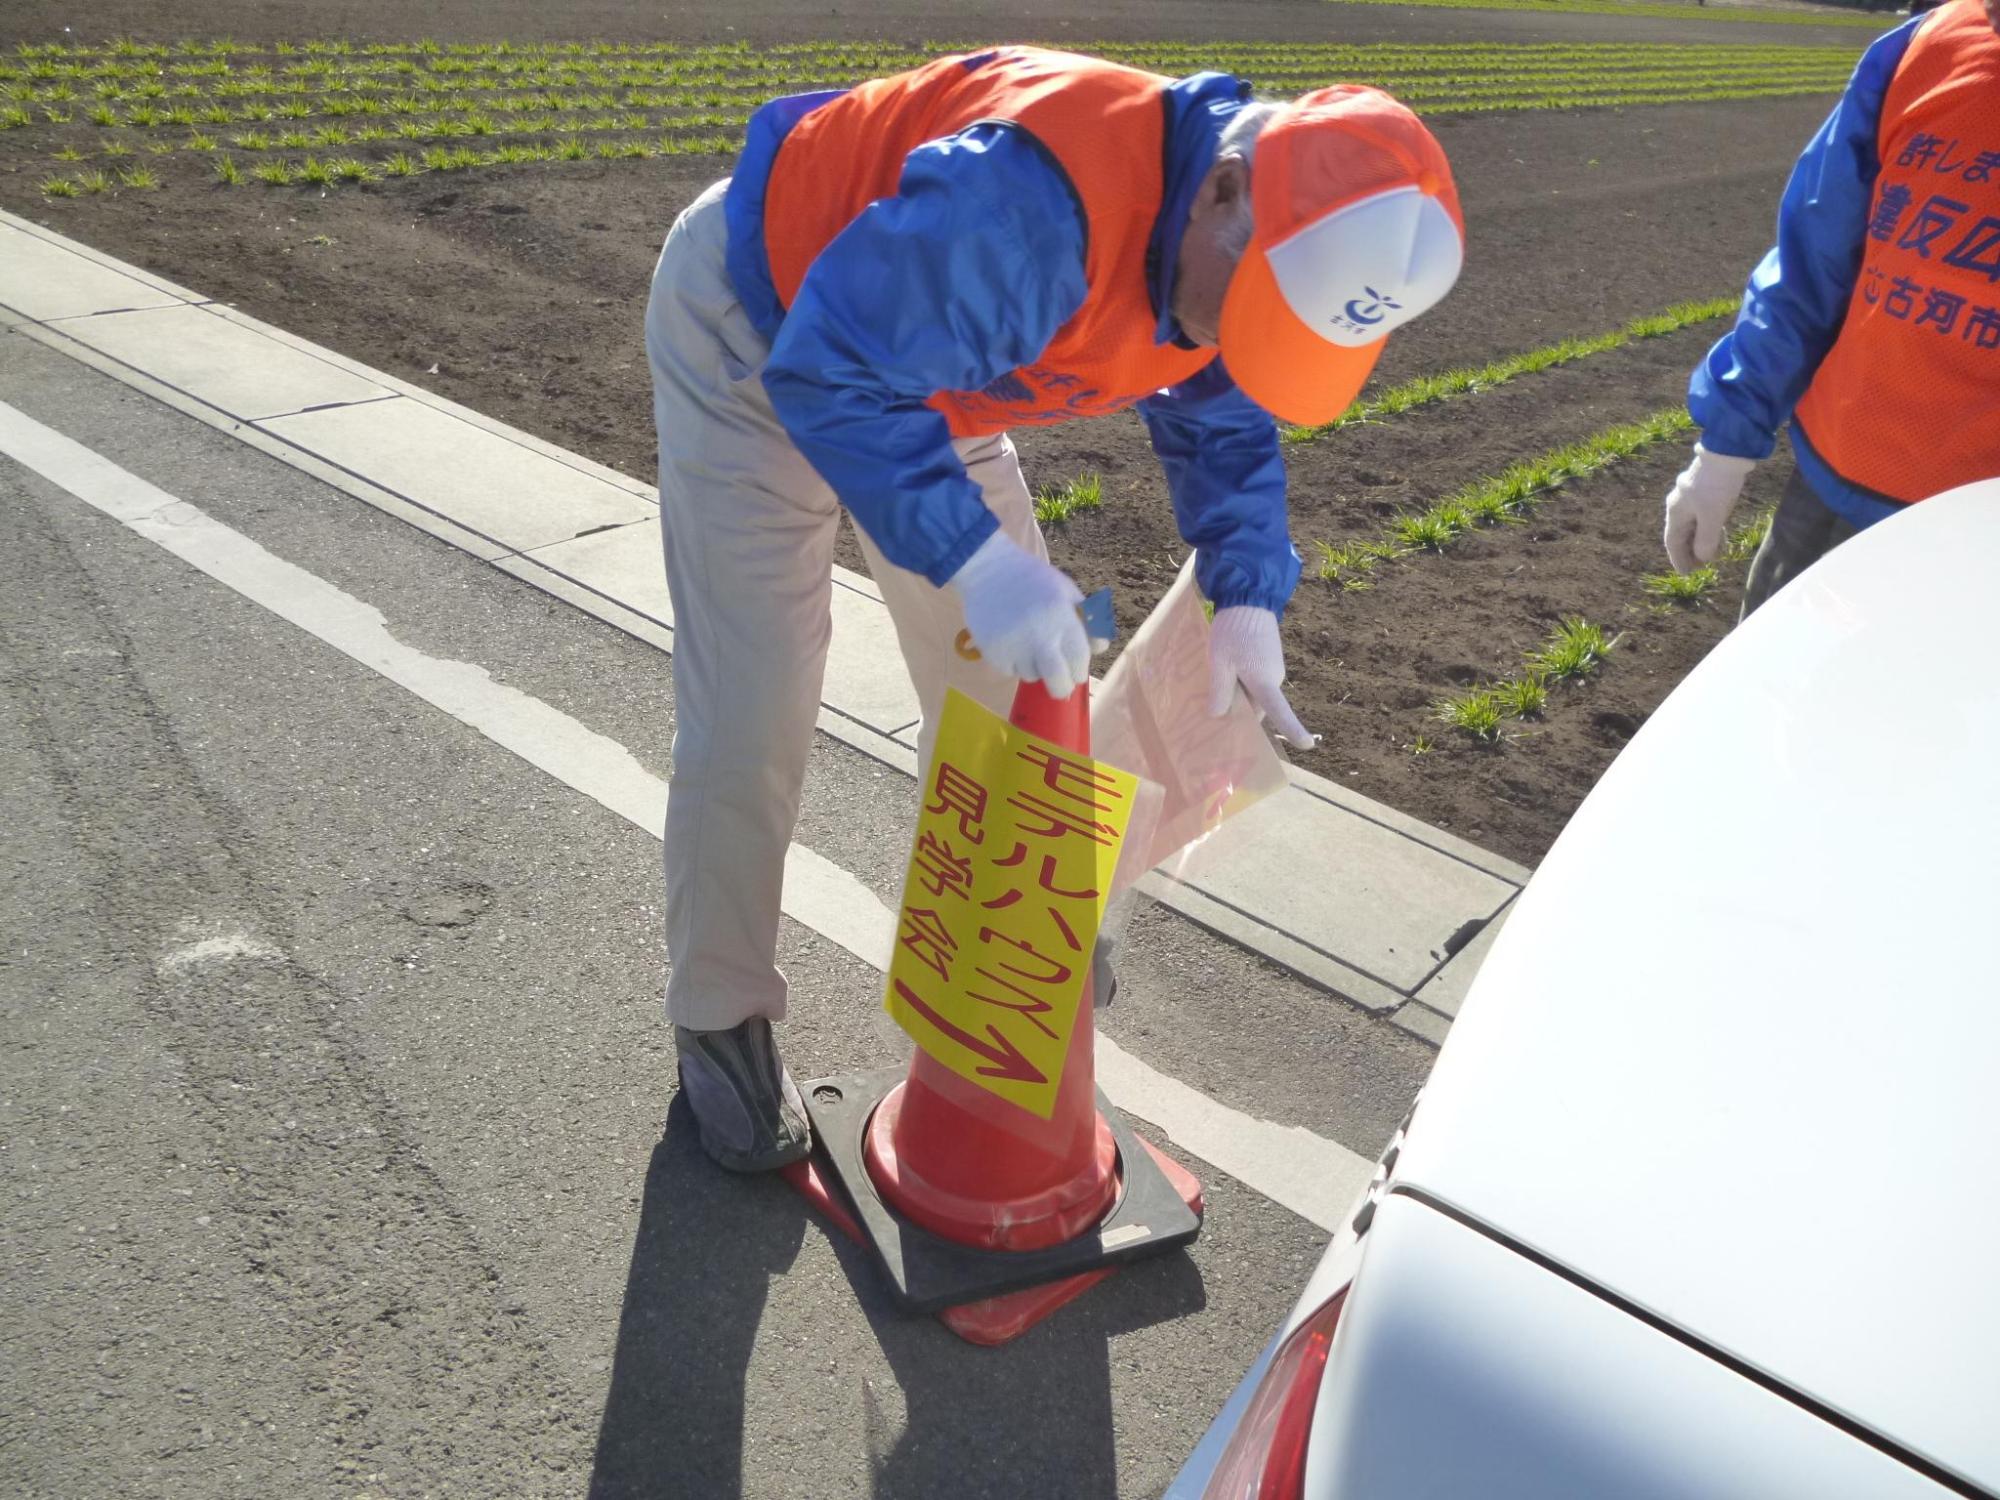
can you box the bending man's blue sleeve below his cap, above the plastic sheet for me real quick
[1138,360,1298,612]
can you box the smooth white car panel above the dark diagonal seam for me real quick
[1396,480,2000,1492]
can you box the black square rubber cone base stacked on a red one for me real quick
[784,1068,1202,1344]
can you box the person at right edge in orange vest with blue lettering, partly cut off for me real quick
[1666,0,2000,614]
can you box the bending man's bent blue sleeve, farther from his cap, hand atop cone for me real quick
[764,122,1086,586]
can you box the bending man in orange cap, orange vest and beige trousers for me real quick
[646,48,1464,1170]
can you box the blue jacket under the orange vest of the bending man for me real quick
[726,74,1300,610]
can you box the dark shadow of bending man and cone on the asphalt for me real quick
[590,1096,1206,1500]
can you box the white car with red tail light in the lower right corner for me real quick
[1168,480,2000,1500]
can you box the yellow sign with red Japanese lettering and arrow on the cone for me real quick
[884,692,1138,1120]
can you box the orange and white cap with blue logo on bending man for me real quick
[1218,84,1466,426]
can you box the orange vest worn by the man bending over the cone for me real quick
[764,48,1216,438]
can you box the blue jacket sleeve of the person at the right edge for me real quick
[1688,16,1922,458]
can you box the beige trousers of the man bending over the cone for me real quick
[646,182,1048,1030]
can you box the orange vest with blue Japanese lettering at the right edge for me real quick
[1796,0,2000,500]
